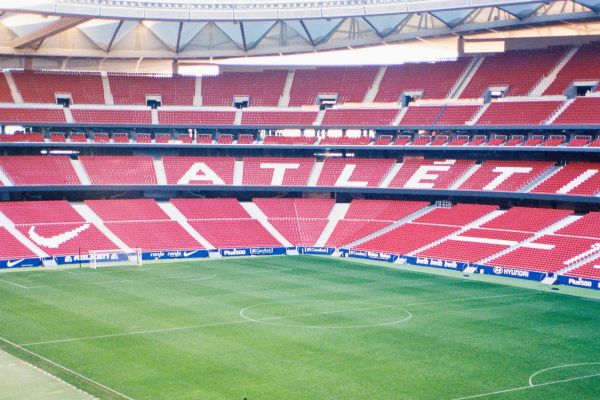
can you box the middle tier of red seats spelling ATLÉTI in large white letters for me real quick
[0,156,600,196]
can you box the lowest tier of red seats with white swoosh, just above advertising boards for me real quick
[0,198,600,278]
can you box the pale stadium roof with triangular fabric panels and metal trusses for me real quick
[0,0,600,62]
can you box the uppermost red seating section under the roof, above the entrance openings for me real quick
[0,43,600,107]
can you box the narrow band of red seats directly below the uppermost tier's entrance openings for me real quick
[0,97,600,127]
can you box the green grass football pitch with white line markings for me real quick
[0,256,600,400]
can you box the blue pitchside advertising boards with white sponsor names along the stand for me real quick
[0,246,600,290]
